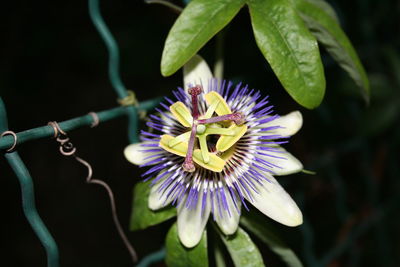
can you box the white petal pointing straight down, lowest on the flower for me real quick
[177,191,211,248]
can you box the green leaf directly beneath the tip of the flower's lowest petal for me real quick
[165,223,208,267]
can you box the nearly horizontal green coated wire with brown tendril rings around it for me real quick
[0,98,160,150]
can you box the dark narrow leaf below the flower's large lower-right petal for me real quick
[240,213,303,267]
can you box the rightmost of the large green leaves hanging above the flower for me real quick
[296,0,370,102]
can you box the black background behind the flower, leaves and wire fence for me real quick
[0,0,400,266]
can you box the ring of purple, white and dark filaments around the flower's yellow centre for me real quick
[137,79,287,219]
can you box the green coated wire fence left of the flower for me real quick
[0,0,160,267]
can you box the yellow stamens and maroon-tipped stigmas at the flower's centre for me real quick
[159,85,247,172]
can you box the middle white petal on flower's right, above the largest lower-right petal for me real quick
[257,146,303,176]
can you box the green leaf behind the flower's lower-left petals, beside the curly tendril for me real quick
[130,181,176,231]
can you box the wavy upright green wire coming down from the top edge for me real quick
[89,0,139,143]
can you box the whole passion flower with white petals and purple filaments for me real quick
[125,56,303,248]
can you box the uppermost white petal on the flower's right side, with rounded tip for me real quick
[256,111,303,136]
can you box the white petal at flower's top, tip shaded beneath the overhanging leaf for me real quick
[183,55,213,92]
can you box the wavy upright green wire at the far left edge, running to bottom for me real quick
[0,98,59,267]
